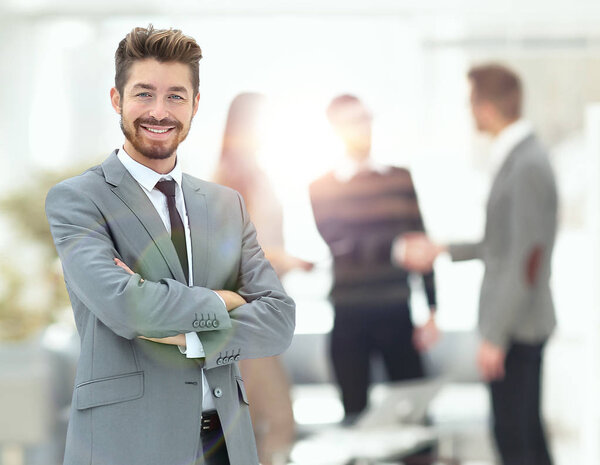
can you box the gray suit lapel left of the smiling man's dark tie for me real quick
[102,151,187,284]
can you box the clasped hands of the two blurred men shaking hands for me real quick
[392,232,446,273]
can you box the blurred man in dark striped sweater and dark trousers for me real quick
[310,95,437,422]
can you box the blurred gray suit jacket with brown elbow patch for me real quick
[449,135,557,348]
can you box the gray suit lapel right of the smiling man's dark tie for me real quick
[182,174,210,287]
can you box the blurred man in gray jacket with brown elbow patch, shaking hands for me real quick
[396,65,557,465]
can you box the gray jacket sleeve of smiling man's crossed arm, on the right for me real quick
[198,190,295,368]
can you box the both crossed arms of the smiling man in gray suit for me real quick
[46,178,295,368]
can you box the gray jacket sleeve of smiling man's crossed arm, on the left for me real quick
[46,180,231,339]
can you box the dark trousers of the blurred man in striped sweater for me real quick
[330,303,423,420]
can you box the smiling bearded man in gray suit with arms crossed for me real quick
[46,26,295,465]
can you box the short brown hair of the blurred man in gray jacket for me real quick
[468,64,523,120]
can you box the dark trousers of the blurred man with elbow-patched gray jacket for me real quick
[490,343,552,465]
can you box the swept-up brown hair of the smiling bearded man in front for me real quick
[115,24,202,97]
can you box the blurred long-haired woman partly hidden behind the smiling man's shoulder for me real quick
[214,93,312,465]
